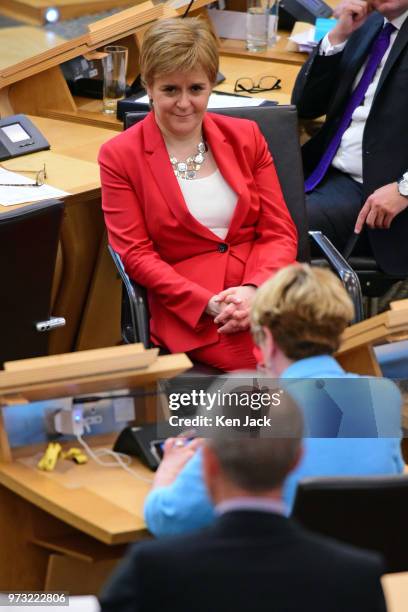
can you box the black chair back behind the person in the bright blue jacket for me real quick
[292,476,408,572]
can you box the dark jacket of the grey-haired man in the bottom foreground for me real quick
[101,511,385,612]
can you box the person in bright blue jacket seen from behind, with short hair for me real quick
[145,264,404,537]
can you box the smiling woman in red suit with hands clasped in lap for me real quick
[99,18,297,370]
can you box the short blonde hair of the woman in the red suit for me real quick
[140,17,219,86]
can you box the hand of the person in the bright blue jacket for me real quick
[152,438,203,489]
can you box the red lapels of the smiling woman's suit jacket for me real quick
[143,112,249,242]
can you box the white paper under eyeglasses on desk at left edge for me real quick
[0,168,70,206]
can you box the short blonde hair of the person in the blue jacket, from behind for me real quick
[251,264,354,361]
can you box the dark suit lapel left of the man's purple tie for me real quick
[332,13,384,114]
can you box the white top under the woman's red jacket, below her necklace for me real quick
[177,168,237,240]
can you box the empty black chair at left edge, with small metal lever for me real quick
[0,200,65,367]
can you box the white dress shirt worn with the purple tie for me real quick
[319,11,408,183]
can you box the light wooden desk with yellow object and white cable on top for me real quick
[0,436,153,594]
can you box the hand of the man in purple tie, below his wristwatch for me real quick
[354,182,408,234]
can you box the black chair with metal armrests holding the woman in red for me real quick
[109,106,363,354]
